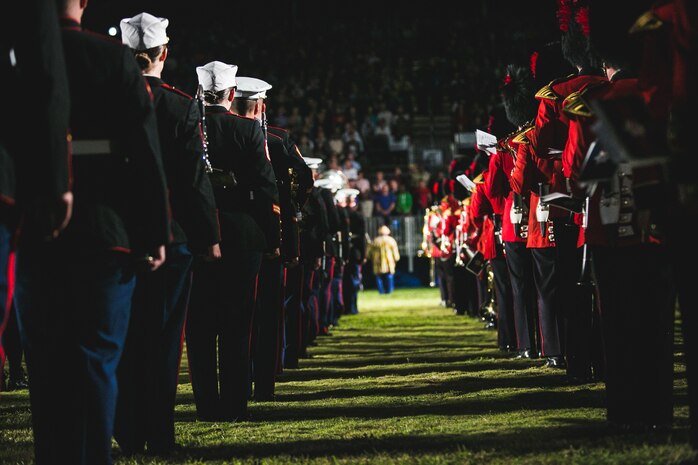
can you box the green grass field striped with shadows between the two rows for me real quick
[0,289,695,465]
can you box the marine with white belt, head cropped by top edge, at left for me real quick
[15,0,169,465]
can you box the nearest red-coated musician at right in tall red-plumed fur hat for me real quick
[563,13,675,430]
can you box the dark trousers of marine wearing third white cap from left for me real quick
[252,258,284,398]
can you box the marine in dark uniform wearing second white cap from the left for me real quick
[186,61,280,421]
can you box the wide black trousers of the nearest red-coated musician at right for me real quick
[594,245,675,426]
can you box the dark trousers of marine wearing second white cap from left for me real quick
[186,250,262,421]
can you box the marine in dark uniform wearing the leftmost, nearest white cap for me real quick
[114,13,220,455]
